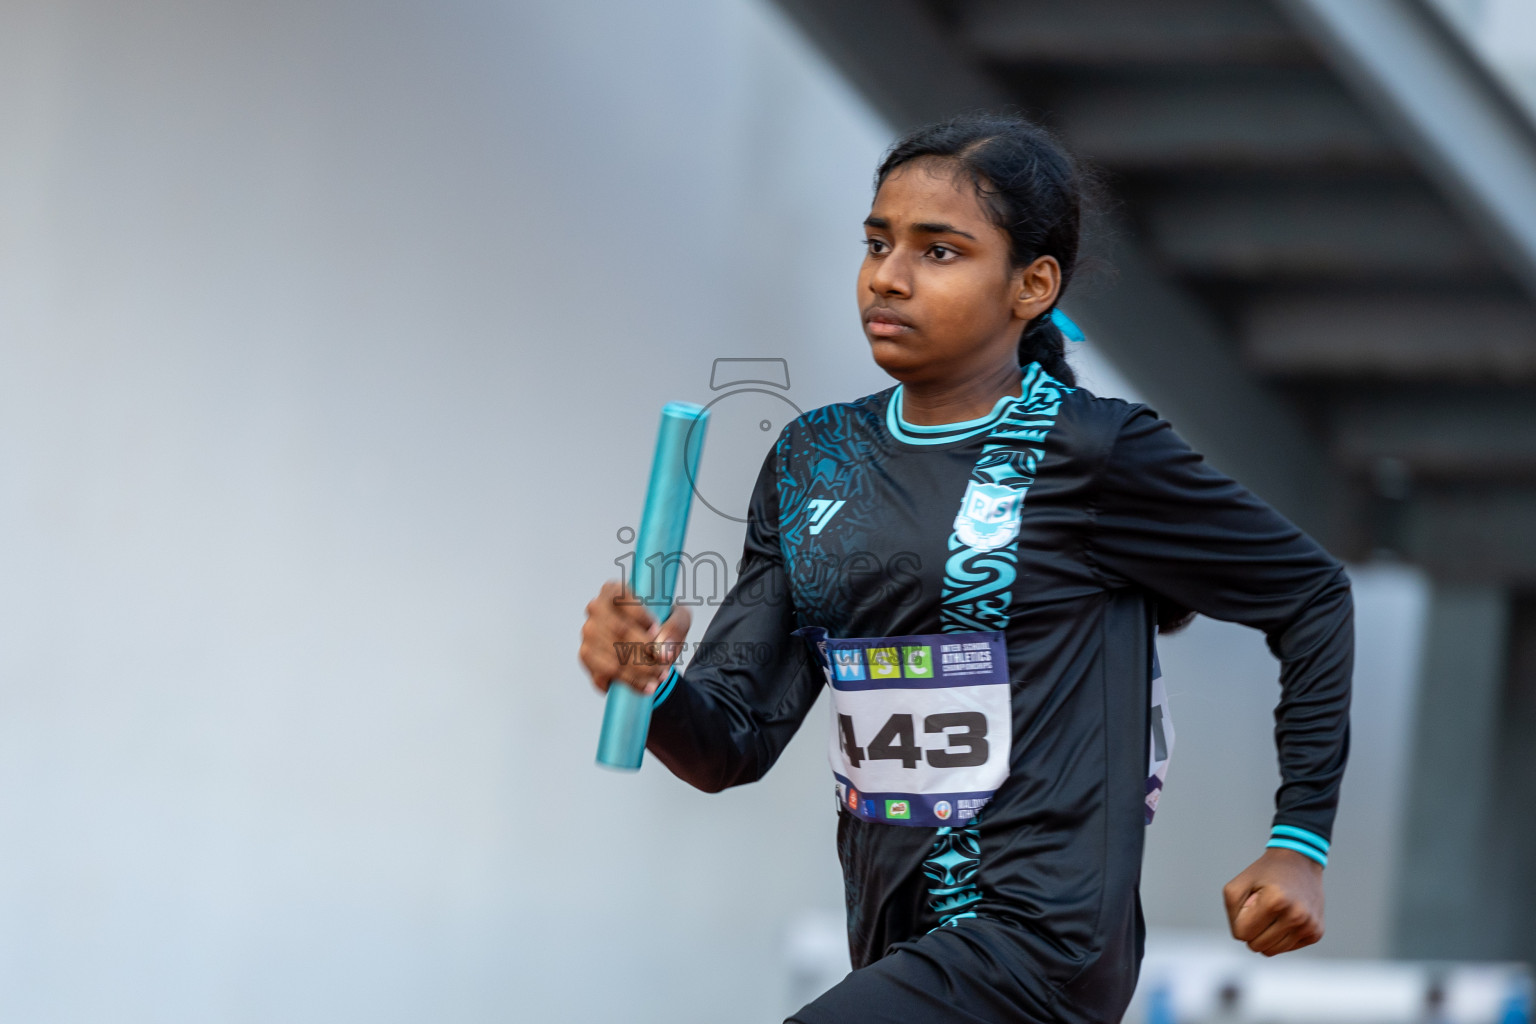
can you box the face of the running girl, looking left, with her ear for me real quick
[859,158,1061,384]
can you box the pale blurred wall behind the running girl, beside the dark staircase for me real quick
[0,0,1431,1024]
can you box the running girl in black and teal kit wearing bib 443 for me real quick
[581,117,1353,1024]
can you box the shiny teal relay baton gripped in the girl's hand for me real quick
[598,402,710,772]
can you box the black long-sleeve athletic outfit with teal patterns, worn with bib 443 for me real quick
[650,364,1353,1021]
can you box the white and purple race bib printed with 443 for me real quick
[796,626,1014,827]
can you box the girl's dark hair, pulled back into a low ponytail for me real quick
[874,114,1086,385]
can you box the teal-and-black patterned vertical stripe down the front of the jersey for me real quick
[923,362,1074,930]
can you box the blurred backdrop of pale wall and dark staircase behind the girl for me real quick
[0,0,1536,1024]
